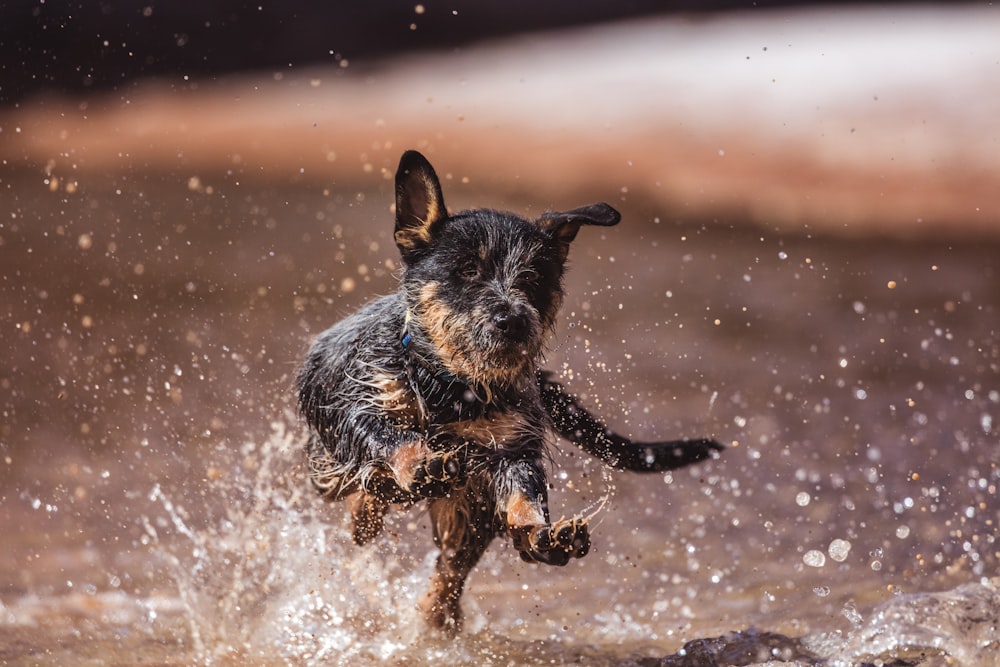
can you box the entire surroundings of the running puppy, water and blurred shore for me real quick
[0,0,1000,665]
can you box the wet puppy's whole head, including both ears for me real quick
[395,151,621,387]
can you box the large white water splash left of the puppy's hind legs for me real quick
[144,423,442,664]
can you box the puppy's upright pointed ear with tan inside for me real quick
[395,151,448,259]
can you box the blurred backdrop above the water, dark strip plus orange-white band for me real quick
[0,1,1000,237]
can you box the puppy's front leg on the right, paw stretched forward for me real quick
[494,458,590,565]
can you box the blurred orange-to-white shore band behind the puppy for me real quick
[0,5,1000,240]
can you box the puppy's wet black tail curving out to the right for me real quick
[538,371,725,472]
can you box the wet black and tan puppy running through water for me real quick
[298,151,722,634]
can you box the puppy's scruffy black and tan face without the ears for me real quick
[404,210,563,385]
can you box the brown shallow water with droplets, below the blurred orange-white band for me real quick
[0,171,1000,665]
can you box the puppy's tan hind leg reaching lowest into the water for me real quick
[420,493,496,637]
